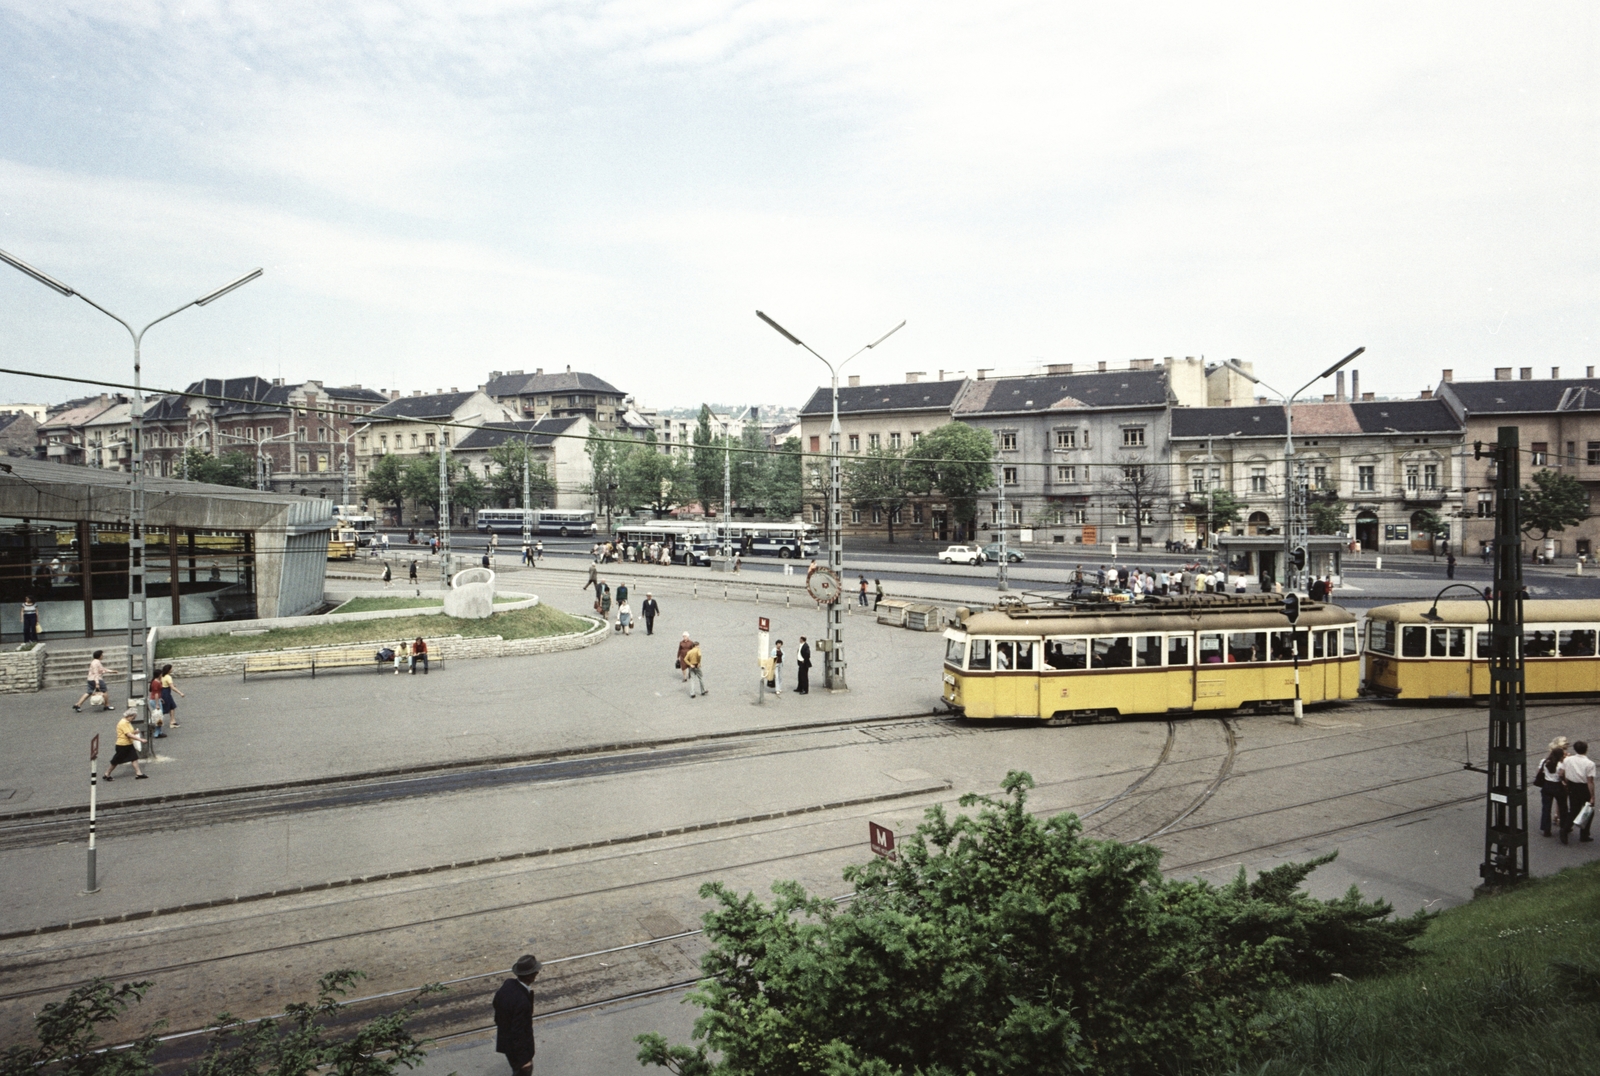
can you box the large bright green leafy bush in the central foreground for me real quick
[637,772,1427,1076]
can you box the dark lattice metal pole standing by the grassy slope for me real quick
[1477,426,1528,889]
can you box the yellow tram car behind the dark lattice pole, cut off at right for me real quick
[1366,600,1600,698]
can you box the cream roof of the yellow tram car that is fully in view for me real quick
[965,599,1350,636]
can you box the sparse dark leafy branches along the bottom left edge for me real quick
[0,969,445,1076]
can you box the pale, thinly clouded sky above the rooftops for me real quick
[0,0,1600,408]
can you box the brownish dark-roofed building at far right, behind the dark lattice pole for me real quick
[1437,367,1600,557]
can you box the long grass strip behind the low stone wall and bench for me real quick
[155,605,589,660]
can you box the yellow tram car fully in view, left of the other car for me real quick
[944,597,1360,722]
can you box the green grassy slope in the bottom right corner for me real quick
[1234,858,1600,1076]
